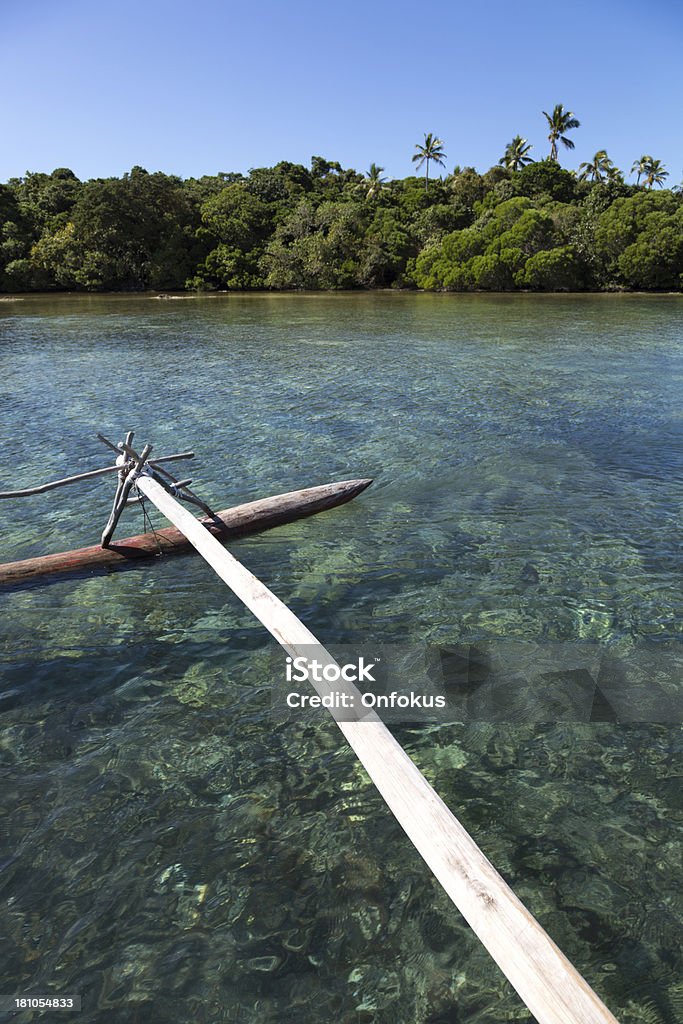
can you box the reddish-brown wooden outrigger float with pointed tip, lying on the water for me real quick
[0,480,372,586]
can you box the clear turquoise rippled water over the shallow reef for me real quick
[0,294,683,1024]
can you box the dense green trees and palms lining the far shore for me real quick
[0,155,683,292]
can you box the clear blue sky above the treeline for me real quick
[0,0,683,184]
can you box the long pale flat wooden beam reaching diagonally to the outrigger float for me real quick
[126,456,617,1024]
